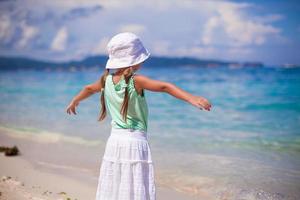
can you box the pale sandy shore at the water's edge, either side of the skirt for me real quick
[0,131,206,200]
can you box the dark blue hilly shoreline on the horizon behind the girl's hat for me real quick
[0,55,265,70]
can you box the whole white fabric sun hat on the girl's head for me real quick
[105,32,150,69]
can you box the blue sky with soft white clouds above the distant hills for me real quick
[0,0,300,65]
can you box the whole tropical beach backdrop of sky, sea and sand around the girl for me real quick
[0,0,300,200]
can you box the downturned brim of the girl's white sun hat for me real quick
[105,50,150,69]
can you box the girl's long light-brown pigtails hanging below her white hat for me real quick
[98,66,133,122]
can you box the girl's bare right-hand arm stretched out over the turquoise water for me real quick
[134,74,211,111]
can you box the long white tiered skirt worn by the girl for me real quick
[96,127,156,200]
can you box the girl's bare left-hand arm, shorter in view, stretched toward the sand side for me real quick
[66,79,102,115]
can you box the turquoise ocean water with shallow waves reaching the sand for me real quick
[0,66,300,199]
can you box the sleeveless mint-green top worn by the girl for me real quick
[104,74,148,132]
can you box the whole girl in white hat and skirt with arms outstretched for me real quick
[66,32,211,200]
